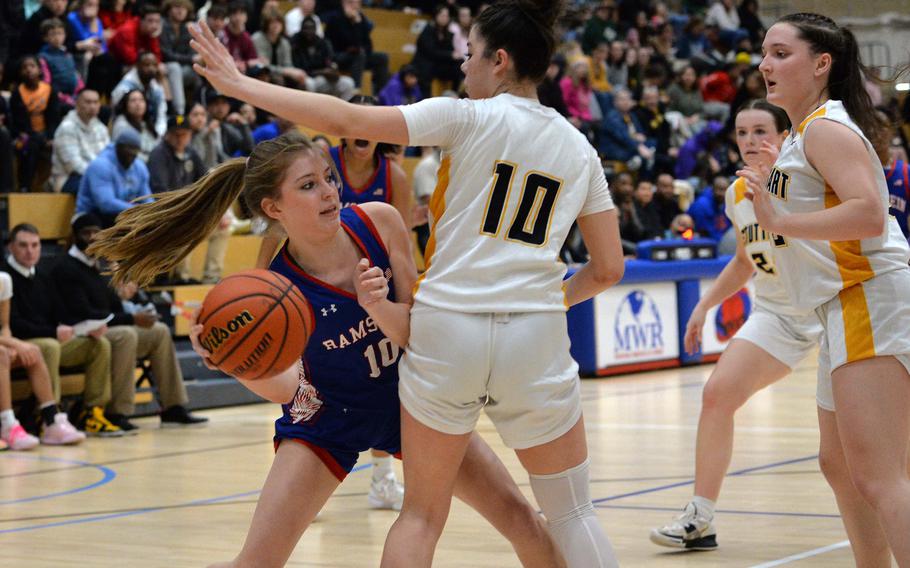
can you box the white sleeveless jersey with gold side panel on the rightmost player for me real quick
[768,100,910,313]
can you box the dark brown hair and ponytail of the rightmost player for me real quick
[778,12,888,163]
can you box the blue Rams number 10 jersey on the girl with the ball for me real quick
[269,205,401,460]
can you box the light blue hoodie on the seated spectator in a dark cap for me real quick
[76,144,152,215]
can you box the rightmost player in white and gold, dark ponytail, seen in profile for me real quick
[739,13,910,566]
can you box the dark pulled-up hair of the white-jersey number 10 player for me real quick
[474,0,563,83]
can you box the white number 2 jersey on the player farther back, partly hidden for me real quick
[725,178,799,316]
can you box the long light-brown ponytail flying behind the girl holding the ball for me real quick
[88,132,322,285]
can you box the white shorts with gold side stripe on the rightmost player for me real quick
[815,268,910,411]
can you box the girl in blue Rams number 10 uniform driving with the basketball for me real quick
[87,133,564,568]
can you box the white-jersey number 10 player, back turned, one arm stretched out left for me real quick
[185,0,623,568]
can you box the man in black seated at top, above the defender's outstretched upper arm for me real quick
[325,0,389,93]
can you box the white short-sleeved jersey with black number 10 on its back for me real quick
[398,94,613,313]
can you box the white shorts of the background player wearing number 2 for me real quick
[734,308,822,369]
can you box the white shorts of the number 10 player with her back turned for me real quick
[398,303,581,449]
